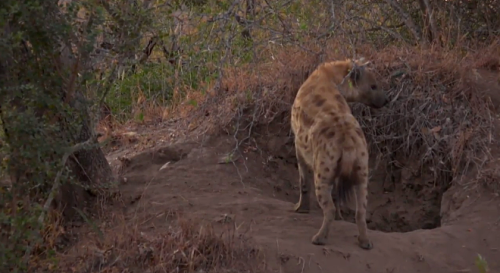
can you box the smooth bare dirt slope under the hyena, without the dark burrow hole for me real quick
[109,133,500,273]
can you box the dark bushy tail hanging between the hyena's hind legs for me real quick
[336,148,357,204]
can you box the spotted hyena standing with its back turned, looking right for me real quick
[291,59,388,249]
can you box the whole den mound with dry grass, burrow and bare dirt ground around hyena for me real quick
[62,41,500,272]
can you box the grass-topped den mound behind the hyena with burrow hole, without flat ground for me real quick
[176,44,500,232]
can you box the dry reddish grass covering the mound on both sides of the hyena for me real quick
[167,38,500,189]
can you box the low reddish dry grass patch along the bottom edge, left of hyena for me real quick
[30,208,266,273]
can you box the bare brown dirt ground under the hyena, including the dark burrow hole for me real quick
[67,66,500,273]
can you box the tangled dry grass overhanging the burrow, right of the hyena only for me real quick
[353,42,499,188]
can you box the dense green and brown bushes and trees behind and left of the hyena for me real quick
[0,0,500,272]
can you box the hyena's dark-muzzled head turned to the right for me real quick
[349,58,389,108]
